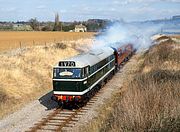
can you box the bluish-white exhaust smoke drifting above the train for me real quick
[93,23,162,51]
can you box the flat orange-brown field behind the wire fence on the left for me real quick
[0,32,95,51]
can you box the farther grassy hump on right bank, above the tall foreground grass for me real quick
[142,40,180,70]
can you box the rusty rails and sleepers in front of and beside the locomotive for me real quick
[26,89,103,132]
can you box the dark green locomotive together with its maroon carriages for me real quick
[52,44,135,107]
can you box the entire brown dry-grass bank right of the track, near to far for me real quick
[102,40,180,132]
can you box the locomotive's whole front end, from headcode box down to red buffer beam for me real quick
[52,61,89,103]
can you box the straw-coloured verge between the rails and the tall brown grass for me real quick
[68,53,142,132]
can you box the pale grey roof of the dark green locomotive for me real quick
[55,47,114,68]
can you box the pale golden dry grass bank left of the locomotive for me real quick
[0,39,91,117]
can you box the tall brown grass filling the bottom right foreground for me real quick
[107,70,180,131]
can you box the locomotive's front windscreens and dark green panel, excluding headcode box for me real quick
[53,67,88,94]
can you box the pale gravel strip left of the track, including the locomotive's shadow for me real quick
[0,92,57,132]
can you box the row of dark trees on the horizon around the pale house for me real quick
[29,13,110,32]
